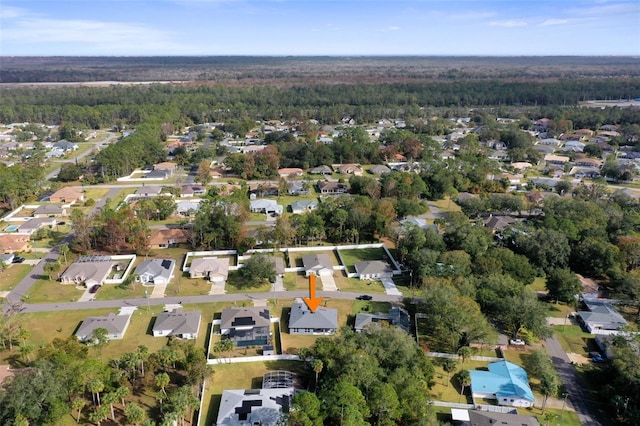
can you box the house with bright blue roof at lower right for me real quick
[469,361,535,408]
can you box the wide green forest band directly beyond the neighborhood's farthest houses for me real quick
[0,79,640,129]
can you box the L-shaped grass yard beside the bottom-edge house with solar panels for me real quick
[199,361,308,425]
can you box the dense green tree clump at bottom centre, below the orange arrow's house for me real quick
[290,326,437,426]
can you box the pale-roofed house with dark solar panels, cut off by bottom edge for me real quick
[215,387,294,426]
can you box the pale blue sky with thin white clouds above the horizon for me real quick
[0,0,640,56]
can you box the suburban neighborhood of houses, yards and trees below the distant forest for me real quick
[0,56,640,426]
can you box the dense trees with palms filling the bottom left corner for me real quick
[0,336,212,425]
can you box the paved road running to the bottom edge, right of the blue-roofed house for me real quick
[544,336,600,426]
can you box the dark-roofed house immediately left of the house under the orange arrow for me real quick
[220,307,271,348]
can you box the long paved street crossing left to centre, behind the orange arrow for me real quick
[22,291,402,312]
